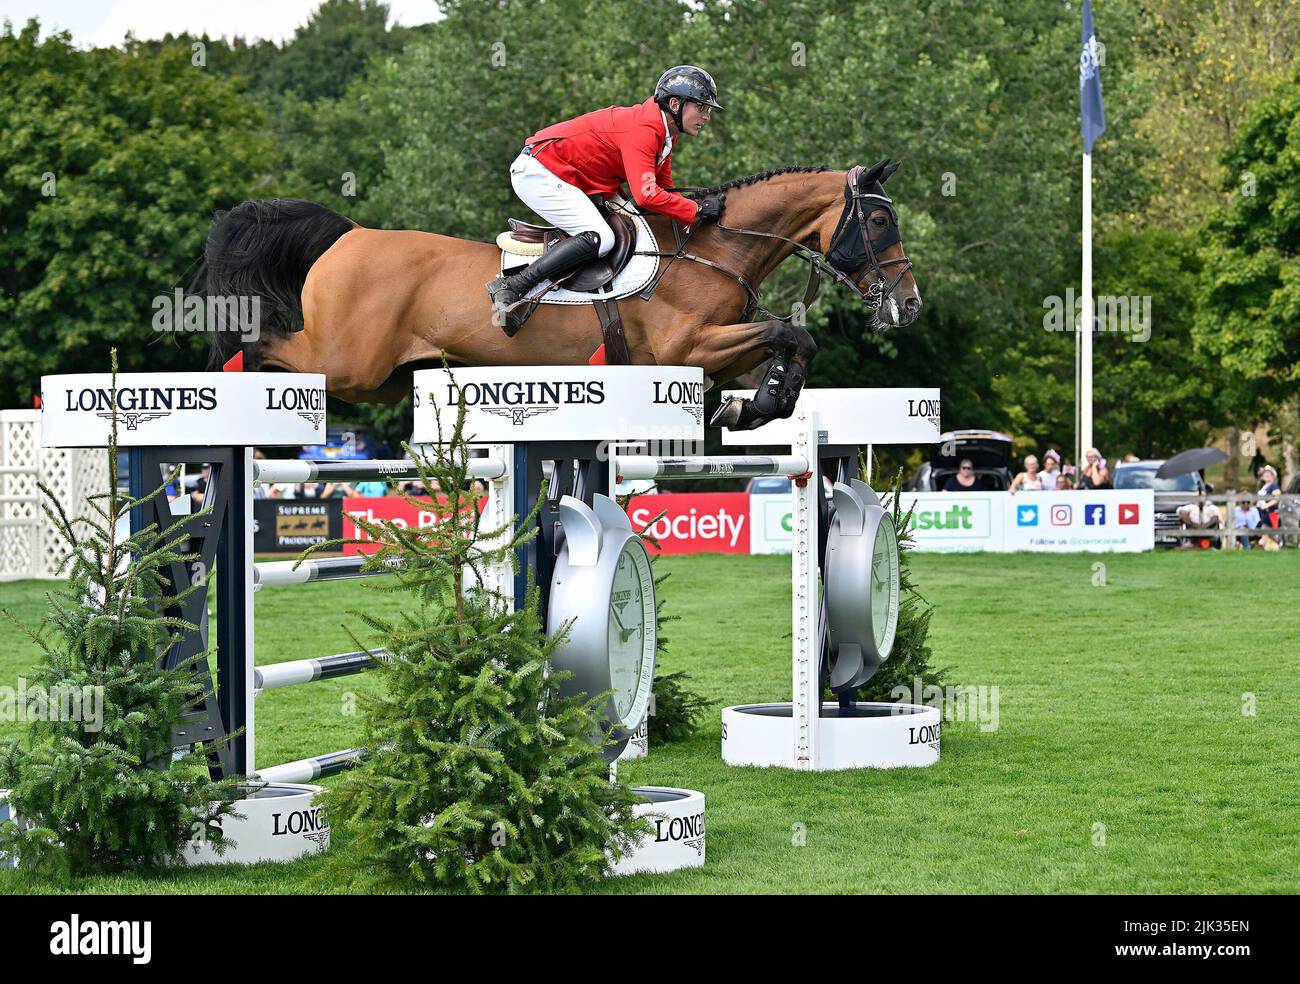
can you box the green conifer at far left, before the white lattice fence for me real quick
[0,350,238,876]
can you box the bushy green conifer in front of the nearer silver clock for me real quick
[321,389,649,893]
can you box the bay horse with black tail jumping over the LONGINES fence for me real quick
[205,160,920,429]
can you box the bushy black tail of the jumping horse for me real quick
[204,199,356,369]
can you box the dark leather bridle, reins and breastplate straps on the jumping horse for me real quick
[637,164,911,328]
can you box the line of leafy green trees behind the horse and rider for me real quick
[0,0,1300,484]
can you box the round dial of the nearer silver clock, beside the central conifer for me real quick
[608,539,658,728]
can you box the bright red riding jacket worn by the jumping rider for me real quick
[525,99,697,224]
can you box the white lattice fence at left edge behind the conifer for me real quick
[0,409,108,581]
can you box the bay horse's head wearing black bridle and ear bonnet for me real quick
[822,160,920,326]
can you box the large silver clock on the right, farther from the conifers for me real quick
[823,478,901,693]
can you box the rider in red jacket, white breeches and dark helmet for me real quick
[488,65,722,335]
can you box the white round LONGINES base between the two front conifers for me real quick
[185,783,329,864]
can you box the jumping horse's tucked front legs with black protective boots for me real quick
[693,320,816,430]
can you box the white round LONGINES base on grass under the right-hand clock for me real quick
[723,701,943,772]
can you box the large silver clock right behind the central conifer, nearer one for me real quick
[546,495,658,741]
